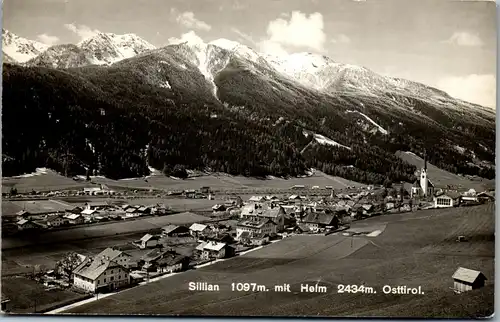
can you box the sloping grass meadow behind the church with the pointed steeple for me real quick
[396,151,495,192]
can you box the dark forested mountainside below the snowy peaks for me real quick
[2,44,495,183]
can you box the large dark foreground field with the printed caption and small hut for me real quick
[64,204,495,318]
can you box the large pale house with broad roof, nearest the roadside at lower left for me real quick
[73,256,130,293]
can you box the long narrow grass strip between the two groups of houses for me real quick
[2,213,210,250]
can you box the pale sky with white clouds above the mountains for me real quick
[3,0,497,108]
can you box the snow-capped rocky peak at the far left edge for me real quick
[2,29,49,63]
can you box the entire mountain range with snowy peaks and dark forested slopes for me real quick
[2,30,495,183]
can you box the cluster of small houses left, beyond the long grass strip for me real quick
[16,201,169,231]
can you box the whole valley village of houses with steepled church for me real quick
[2,157,494,314]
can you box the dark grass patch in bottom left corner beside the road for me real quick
[2,277,86,313]
